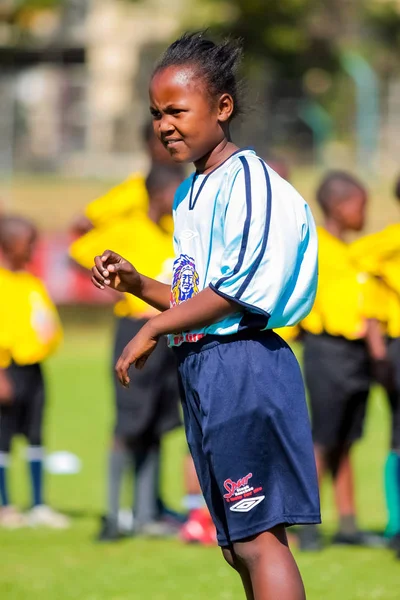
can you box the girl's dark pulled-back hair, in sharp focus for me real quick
[153,31,243,118]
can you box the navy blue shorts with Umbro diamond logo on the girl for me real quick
[175,331,321,546]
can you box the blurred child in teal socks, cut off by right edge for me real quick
[350,179,400,556]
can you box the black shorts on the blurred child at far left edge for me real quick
[0,364,45,452]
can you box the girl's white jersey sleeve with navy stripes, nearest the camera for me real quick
[210,156,271,312]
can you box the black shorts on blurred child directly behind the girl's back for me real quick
[304,333,371,449]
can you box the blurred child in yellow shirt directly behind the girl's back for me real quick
[301,171,382,549]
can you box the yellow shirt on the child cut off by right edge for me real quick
[350,223,400,337]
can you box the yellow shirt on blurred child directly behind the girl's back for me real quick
[302,227,377,340]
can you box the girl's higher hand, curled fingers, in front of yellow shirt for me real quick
[92,250,140,294]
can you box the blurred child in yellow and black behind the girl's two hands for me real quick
[70,163,182,541]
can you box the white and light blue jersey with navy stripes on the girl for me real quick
[169,149,317,346]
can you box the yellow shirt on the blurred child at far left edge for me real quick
[0,268,62,368]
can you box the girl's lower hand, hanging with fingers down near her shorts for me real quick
[115,321,158,387]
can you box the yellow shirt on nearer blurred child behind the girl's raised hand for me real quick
[70,210,174,317]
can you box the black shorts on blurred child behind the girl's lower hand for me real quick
[113,318,181,442]
